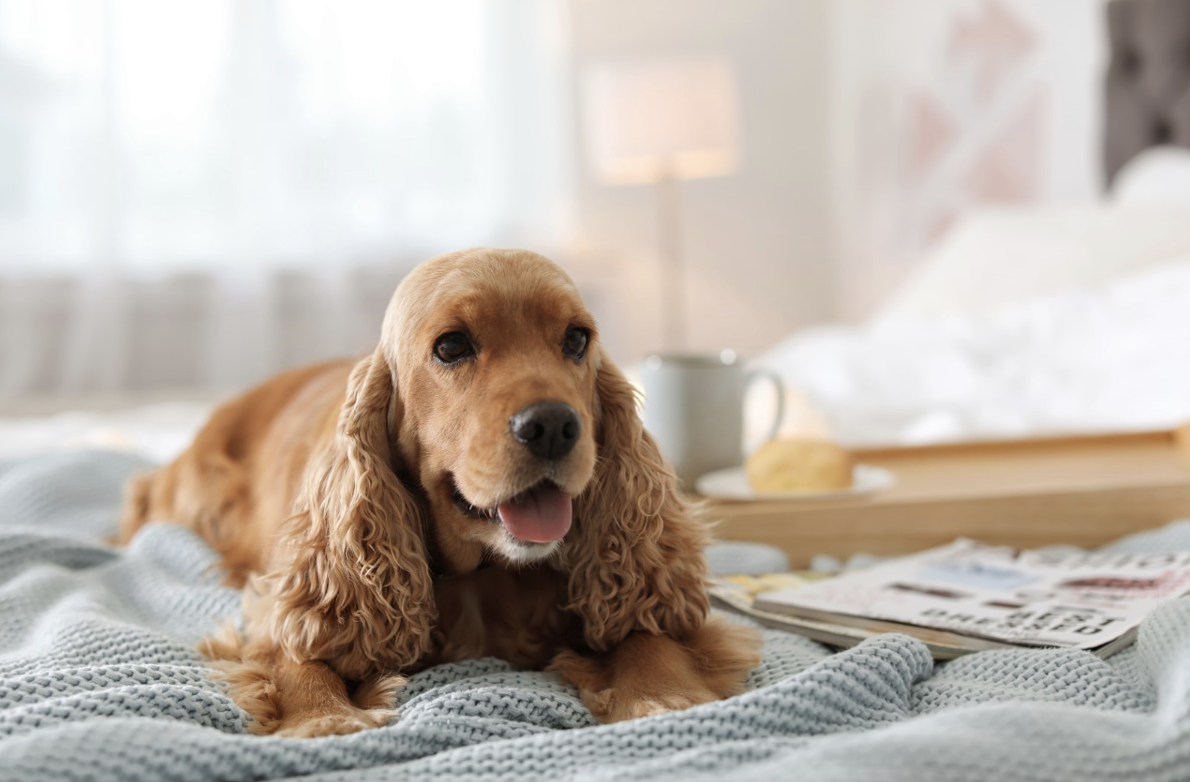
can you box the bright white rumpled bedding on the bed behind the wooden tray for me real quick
[750,255,1190,445]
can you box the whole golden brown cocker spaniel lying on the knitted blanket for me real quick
[120,250,758,736]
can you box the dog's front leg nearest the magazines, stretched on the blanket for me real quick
[549,618,760,722]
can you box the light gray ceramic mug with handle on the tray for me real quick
[640,350,785,490]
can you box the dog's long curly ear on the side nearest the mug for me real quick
[568,350,708,651]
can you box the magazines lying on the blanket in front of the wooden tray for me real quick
[712,539,1190,659]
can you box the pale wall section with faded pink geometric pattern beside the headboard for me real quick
[828,0,1107,318]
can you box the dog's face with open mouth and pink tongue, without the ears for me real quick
[384,250,599,571]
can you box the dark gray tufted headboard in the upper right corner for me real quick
[1103,0,1190,183]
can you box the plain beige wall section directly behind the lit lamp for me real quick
[569,0,833,359]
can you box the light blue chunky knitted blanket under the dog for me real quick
[0,453,1190,782]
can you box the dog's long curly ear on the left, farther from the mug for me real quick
[268,348,436,678]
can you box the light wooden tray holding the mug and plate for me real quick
[708,425,1190,568]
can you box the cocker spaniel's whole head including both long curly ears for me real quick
[273,250,708,675]
